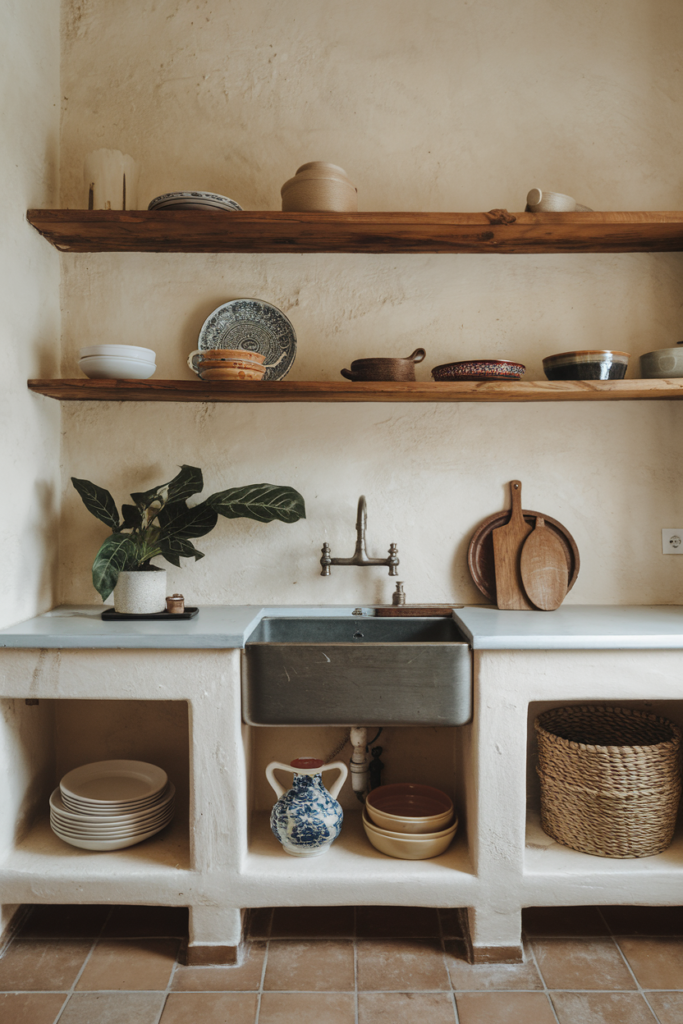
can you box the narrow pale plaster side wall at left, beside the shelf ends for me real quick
[0,0,60,627]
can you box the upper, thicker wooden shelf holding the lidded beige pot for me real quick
[28,210,683,253]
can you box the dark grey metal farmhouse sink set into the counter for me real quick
[242,615,472,725]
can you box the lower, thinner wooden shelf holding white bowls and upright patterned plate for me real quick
[29,378,683,402]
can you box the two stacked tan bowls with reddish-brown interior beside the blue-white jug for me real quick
[362,782,458,860]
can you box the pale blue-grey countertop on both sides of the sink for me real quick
[0,604,683,650]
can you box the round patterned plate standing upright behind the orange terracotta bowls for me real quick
[193,299,296,381]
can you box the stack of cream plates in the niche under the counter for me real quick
[50,761,175,850]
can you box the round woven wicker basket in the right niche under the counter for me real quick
[535,706,681,858]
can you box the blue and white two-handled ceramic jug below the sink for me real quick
[265,758,348,857]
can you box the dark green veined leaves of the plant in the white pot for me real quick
[71,466,306,601]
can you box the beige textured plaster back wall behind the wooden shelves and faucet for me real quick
[57,0,683,604]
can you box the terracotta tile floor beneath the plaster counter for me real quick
[0,906,683,1024]
